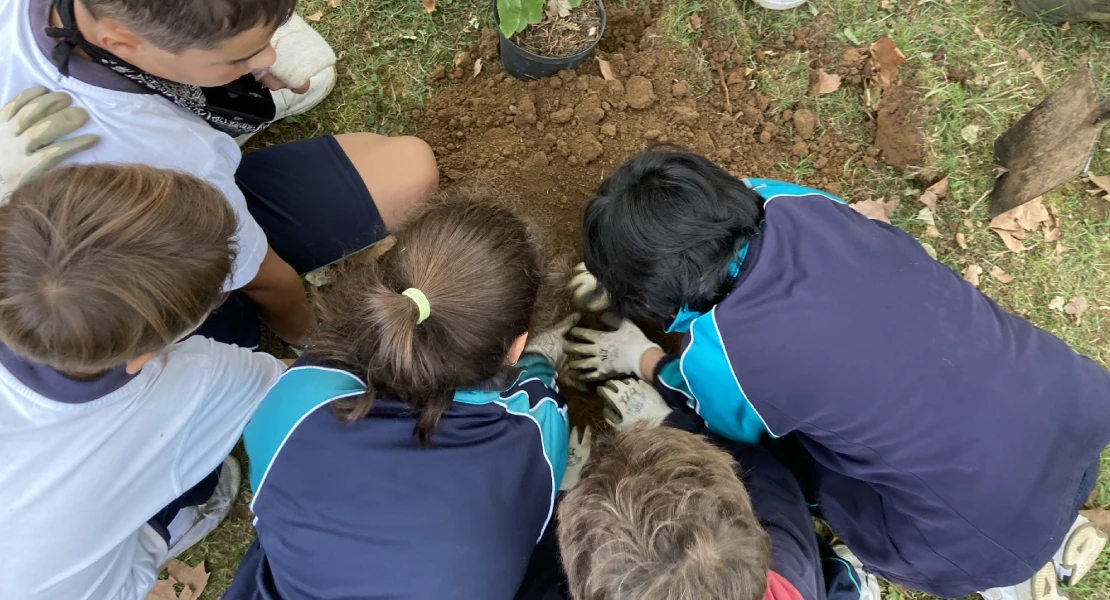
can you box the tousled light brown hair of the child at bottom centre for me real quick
[558,426,770,600]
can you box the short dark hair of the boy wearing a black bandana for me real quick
[79,0,296,53]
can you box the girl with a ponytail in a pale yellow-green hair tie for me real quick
[225,202,573,600]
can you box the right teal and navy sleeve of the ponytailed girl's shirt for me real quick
[502,354,571,490]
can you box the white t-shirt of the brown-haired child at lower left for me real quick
[0,337,284,600]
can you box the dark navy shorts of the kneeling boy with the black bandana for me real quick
[194,131,386,348]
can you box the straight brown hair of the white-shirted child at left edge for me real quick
[0,164,236,375]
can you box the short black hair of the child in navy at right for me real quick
[582,146,764,321]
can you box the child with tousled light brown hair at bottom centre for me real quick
[558,382,879,600]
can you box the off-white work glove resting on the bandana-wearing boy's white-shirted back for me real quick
[0,85,100,203]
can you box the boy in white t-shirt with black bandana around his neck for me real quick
[0,0,438,346]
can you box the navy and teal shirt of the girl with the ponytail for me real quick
[225,355,568,600]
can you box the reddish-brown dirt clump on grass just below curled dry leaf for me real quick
[875,85,925,169]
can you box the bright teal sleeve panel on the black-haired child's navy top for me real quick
[674,308,776,444]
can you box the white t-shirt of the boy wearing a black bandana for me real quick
[0,0,266,289]
